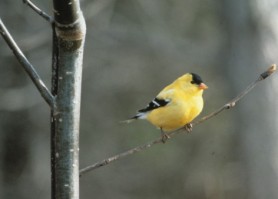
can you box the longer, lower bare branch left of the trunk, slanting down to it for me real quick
[0,18,55,108]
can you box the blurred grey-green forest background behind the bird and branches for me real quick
[0,0,278,199]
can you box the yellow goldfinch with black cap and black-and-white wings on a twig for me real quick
[126,73,208,142]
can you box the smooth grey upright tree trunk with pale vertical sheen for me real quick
[51,0,86,199]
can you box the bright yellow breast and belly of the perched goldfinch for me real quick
[147,92,203,131]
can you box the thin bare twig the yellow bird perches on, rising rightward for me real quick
[79,64,276,176]
